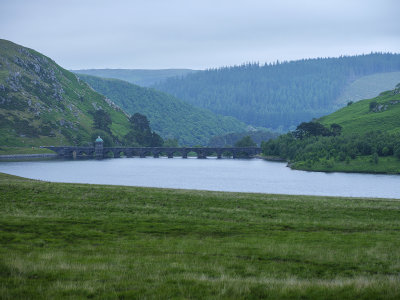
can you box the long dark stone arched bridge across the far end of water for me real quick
[43,145,261,158]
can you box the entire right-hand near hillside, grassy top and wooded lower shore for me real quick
[262,84,400,174]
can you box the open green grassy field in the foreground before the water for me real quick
[0,173,400,299]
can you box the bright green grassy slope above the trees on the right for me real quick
[320,84,400,133]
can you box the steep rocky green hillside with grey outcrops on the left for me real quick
[0,40,129,146]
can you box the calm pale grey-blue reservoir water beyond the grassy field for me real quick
[0,158,400,199]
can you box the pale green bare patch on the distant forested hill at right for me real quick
[337,72,400,105]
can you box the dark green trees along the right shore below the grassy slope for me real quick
[262,122,400,165]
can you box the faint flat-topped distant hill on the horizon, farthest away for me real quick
[72,69,196,87]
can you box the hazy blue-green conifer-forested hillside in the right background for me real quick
[154,53,400,130]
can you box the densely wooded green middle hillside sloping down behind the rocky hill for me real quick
[78,74,246,145]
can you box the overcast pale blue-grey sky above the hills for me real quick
[0,0,400,69]
